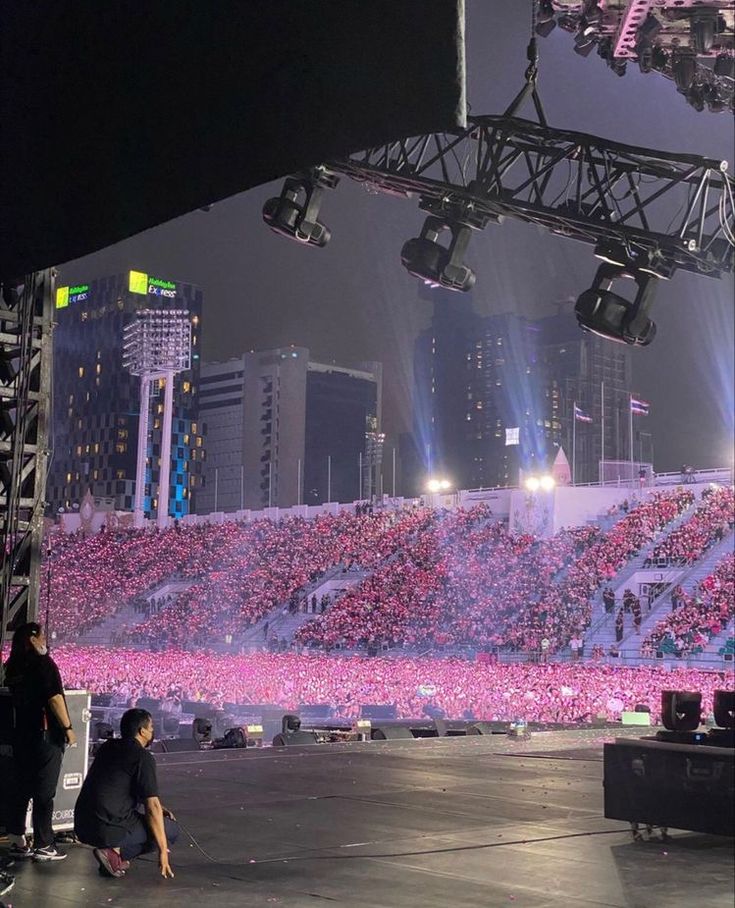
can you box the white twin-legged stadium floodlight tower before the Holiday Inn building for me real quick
[123,309,191,528]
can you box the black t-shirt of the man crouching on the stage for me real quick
[74,738,158,848]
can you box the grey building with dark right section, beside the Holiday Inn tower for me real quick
[197,347,383,514]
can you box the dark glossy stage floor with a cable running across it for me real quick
[6,729,734,908]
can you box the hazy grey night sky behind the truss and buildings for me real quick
[60,0,735,471]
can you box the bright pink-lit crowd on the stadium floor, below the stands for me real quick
[53,645,731,722]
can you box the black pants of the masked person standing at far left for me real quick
[8,736,64,848]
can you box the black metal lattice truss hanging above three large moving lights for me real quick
[330,115,735,278]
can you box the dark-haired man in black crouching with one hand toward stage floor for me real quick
[74,709,179,877]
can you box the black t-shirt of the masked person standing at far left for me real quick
[7,655,66,746]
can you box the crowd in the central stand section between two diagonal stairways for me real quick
[296,489,694,655]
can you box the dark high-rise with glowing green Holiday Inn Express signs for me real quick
[47,271,204,517]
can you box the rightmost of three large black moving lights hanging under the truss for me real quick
[574,263,656,347]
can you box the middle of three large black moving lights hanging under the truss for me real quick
[401,215,476,293]
